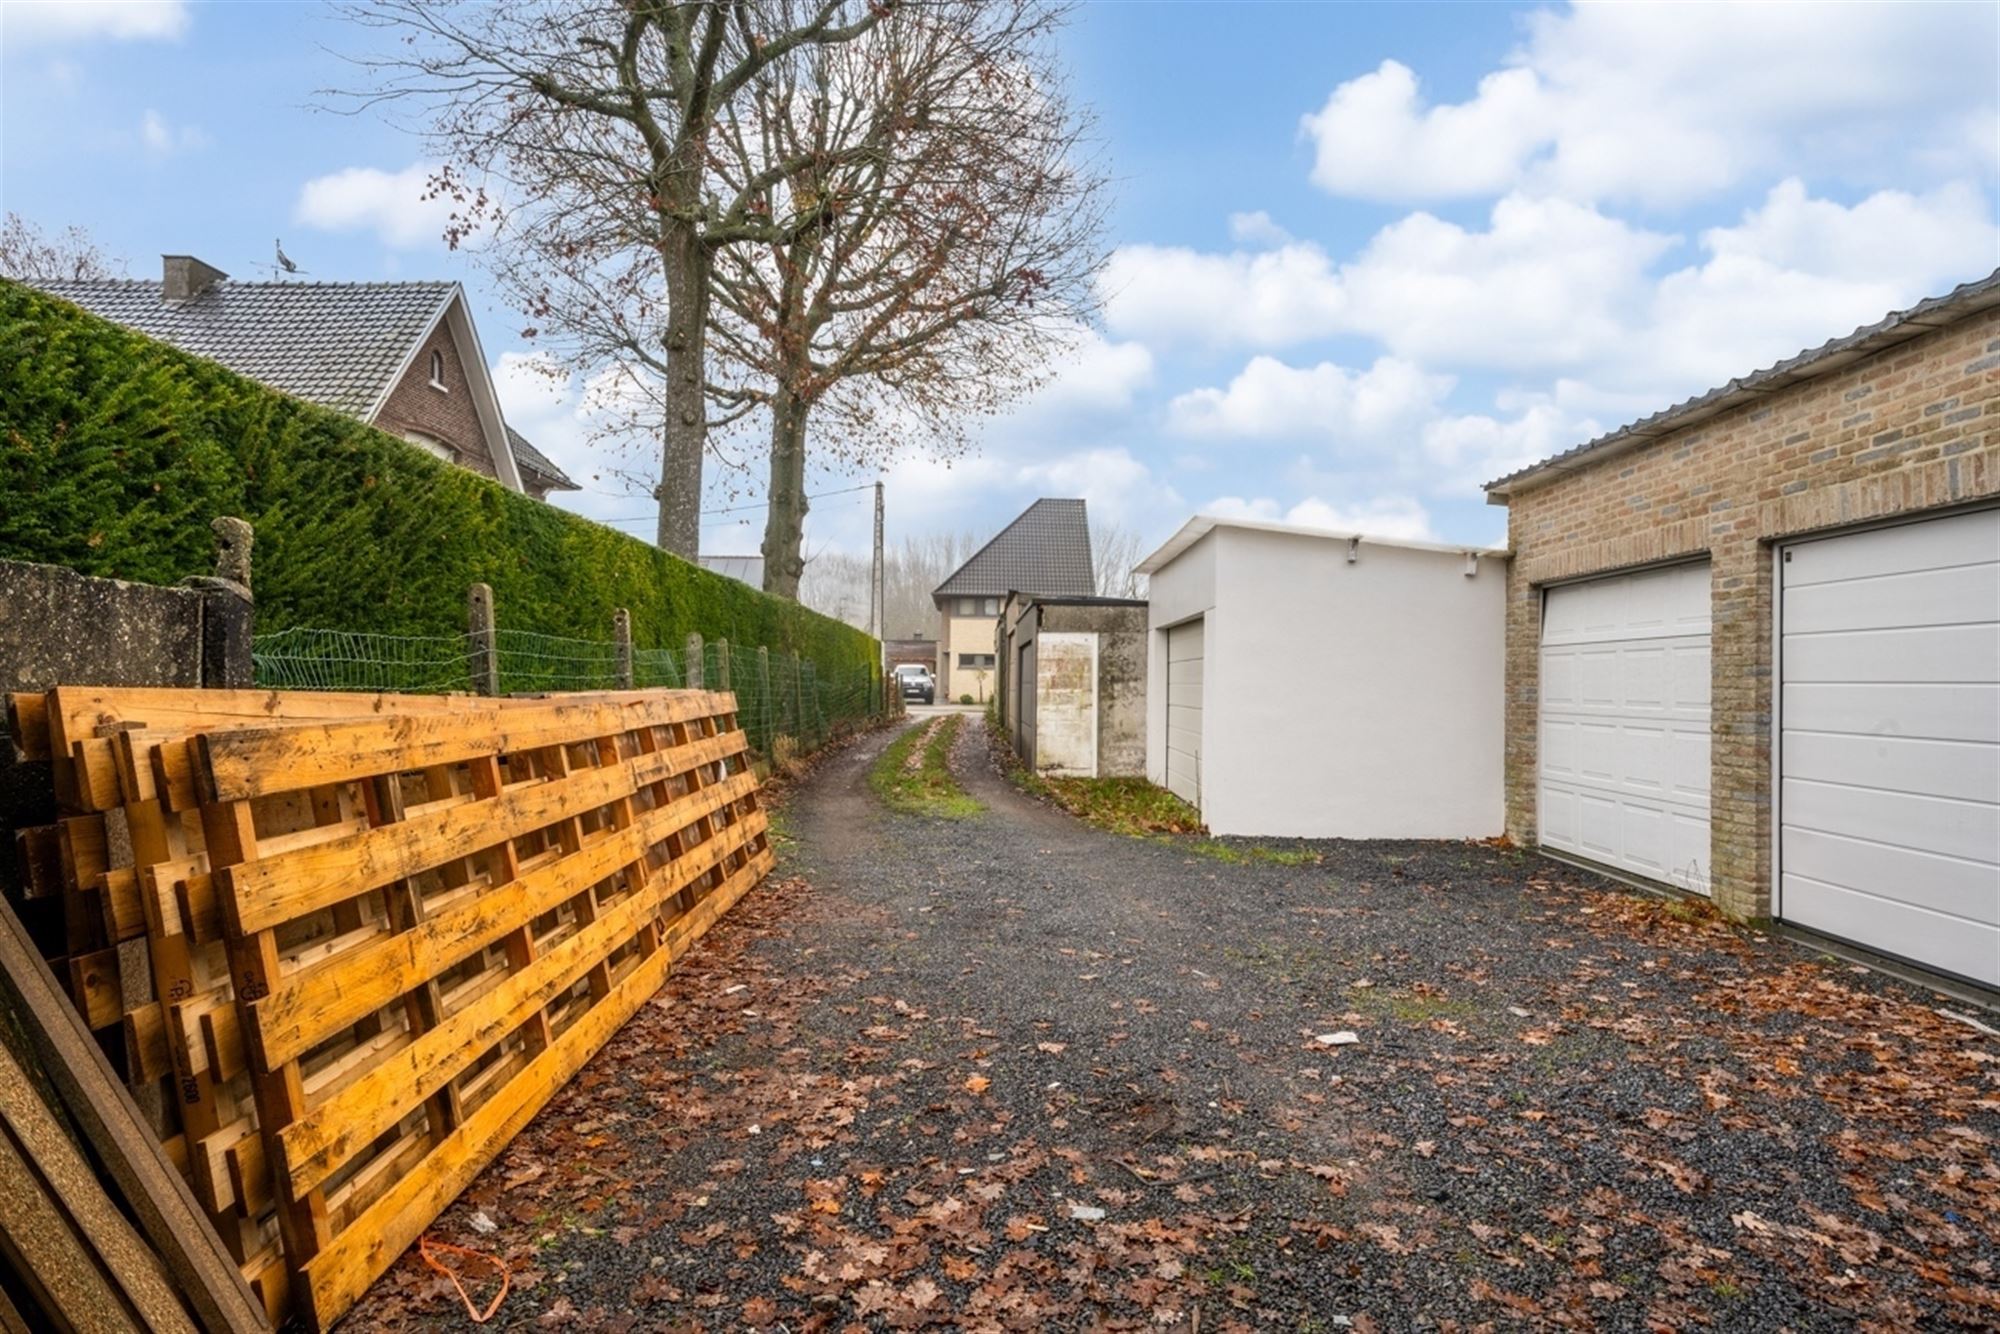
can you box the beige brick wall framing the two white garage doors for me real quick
[1506,310,2000,918]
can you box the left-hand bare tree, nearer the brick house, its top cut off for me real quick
[336,0,898,558]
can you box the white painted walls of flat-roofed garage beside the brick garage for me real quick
[1148,526,1506,838]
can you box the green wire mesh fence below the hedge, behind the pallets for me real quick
[252,628,900,756]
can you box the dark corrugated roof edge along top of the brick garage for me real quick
[1486,268,2000,504]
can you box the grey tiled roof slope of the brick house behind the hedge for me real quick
[40,278,458,418]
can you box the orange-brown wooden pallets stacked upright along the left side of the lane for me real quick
[10,686,772,1326]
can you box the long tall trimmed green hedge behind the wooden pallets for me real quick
[0,280,878,680]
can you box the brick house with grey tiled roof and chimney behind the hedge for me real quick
[40,254,578,500]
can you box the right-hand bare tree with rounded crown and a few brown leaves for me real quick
[712,0,1104,596]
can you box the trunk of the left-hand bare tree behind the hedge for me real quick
[654,222,712,560]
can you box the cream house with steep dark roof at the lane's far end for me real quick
[930,500,1098,704]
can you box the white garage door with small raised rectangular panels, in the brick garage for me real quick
[1540,562,1710,894]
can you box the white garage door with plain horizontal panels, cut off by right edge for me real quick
[1778,510,2000,986]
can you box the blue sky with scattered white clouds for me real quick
[0,0,2000,568]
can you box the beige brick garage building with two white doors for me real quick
[1488,272,2000,986]
